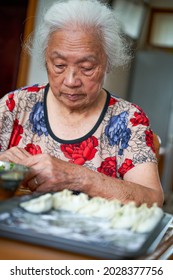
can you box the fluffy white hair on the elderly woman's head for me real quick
[26,0,130,69]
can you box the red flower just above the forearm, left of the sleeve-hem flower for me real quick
[97,157,117,178]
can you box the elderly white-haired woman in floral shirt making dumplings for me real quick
[0,0,163,207]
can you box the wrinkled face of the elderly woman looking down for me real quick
[46,28,107,109]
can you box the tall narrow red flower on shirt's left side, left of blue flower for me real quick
[8,119,23,148]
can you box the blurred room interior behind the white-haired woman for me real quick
[0,0,173,213]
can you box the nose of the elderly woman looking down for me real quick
[64,68,81,87]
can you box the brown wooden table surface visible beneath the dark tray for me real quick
[0,188,173,260]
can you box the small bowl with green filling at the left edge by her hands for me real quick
[0,161,29,200]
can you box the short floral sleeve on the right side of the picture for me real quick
[117,103,157,178]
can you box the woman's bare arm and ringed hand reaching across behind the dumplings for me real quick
[19,151,163,207]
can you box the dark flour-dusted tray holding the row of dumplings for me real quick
[0,196,173,259]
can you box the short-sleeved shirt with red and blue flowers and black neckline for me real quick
[0,84,157,178]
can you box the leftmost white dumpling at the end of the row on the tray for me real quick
[19,193,53,214]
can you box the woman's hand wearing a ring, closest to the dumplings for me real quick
[22,154,82,192]
